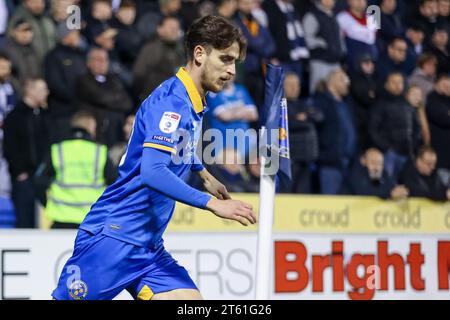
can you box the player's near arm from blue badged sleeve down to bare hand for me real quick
[141,101,256,225]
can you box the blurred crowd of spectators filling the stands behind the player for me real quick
[0,0,450,228]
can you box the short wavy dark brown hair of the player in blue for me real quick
[185,15,247,61]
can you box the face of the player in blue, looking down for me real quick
[201,42,239,92]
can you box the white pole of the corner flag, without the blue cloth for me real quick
[256,127,275,300]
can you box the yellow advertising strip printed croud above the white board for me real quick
[168,194,450,234]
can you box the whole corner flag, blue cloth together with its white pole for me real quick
[255,64,291,300]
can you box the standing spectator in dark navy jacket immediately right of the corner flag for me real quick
[284,73,323,193]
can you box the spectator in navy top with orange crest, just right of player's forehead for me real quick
[235,0,275,107]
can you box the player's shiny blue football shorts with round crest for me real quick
[52,229,197,300]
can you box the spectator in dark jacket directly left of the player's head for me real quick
[133,17,185,102]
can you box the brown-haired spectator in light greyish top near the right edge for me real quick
[408,53,437,97]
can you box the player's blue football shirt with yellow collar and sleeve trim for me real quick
[80,68,206,247]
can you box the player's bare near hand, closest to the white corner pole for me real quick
[206,198,256,226]
